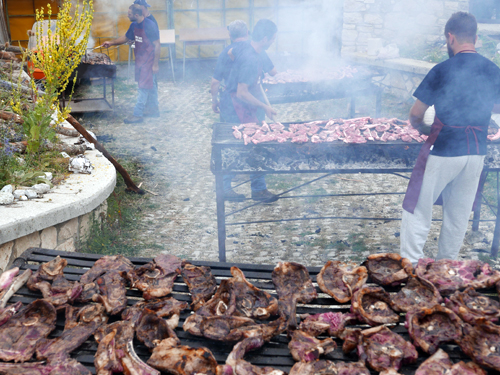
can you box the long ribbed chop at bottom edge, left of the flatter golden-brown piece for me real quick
[94,320,160,375]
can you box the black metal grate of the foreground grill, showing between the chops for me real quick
[9,248,500,375]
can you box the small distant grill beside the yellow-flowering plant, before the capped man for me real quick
[63,52,116,113]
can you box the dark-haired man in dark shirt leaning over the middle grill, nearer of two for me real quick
[220,19,278,203]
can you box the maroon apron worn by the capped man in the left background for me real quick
[134,20,155,90]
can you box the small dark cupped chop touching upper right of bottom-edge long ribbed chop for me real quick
[135,309,180,349]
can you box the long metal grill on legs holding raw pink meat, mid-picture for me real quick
[211,123,500,261]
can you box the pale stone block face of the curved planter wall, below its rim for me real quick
[0,201,108,270]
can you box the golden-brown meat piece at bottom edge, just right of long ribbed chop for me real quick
[147,338,217,375]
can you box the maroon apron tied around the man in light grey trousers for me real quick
[403,117,484,214]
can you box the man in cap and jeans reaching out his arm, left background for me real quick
[102,4,160,124]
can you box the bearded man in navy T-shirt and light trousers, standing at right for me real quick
[401,12,500,265]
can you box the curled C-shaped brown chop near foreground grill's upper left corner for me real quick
[26,256,82,307]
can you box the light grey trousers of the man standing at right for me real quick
[401,155,484,265]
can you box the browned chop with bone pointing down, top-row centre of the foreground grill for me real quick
[272,262,318,329]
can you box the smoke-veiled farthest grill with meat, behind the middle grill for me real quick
[262,67,382,118]
